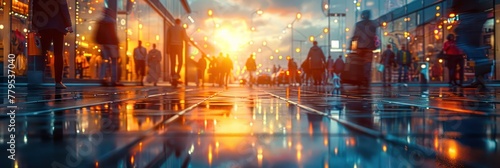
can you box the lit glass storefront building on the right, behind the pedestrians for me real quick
[378,0,499,82]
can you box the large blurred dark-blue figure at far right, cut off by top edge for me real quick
[451,0,493,92]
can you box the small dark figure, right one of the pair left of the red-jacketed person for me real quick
[397,45,412,86]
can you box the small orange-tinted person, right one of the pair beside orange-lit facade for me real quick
[146,44,162,86]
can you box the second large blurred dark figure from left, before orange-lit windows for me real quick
[94,8,123,86]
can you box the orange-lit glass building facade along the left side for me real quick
[0,0,199,81]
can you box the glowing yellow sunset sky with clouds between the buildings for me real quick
[183,0,373,66]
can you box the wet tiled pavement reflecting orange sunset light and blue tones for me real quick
[0,86,500,168]
